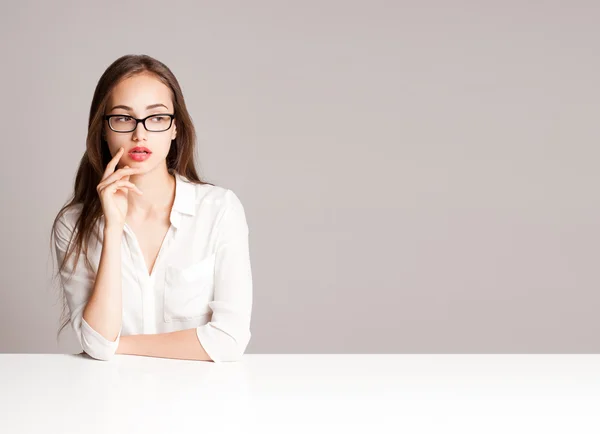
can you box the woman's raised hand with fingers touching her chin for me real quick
[96,148,143,229]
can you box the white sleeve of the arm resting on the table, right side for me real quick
[196,190,252,362]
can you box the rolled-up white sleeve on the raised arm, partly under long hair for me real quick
[54,214,121,360]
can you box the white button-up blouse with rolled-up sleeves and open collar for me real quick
[55,173,252,362]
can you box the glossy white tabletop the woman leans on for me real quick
[0,354,600,434]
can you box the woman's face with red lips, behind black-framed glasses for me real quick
[103,74,177,173]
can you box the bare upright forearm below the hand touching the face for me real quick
[83,228,123,341]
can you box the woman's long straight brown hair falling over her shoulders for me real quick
[50,54,214,340]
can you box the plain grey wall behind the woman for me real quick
[0,0,600,353]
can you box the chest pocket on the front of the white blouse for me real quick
[164,253,216,322]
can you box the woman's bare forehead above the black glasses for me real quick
[107,74,173,112]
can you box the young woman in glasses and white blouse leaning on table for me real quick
[51,55,252,362]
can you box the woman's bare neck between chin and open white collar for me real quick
[127,166,176,220]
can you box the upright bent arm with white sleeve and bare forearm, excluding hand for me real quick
[54,215,121,360]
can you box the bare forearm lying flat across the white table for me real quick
[117,328,212,361]
